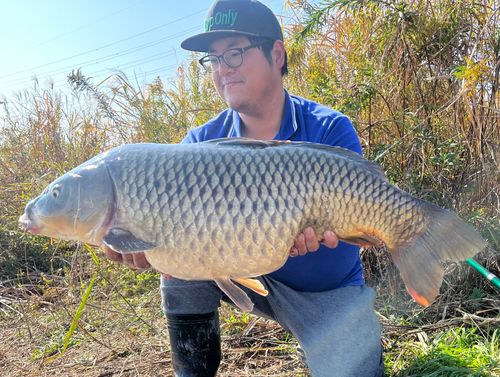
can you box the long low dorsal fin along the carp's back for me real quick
[202,137,387,180]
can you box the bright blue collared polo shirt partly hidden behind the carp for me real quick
[182,91,364,292]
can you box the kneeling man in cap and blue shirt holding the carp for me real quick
[107,0,383,377]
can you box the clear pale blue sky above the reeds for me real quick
[0,0,285,99]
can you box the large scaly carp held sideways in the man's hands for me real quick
[19,139,485,310]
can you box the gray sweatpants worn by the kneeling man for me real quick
[161,276,384,377]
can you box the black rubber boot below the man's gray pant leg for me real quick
[167,311,222,377]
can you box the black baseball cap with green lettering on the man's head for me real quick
[181,0,283,52]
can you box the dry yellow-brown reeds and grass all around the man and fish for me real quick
[0,0,500,377]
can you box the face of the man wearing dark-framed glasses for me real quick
[208,37,281,115]
